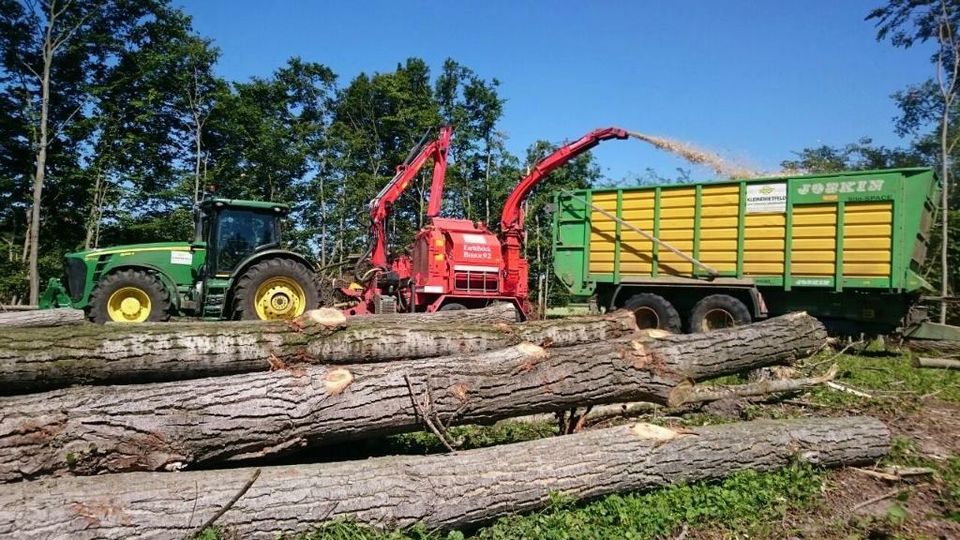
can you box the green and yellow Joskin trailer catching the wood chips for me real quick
[553,168,940,334]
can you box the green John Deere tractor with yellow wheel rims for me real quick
[40,198,320,323]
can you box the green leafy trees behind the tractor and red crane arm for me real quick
[0,0,548,302]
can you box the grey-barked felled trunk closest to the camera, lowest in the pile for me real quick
[0,416,890,539]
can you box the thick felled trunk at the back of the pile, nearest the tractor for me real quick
[0,304,636,395]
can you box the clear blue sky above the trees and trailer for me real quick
[179,0,932,180]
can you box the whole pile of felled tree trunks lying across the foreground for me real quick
[0,306,889,538]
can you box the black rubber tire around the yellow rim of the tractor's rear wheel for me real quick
[233,258,320,320]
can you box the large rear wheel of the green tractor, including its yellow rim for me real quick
[233,259,320,320]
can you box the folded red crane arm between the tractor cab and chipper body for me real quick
[370,126,453,267]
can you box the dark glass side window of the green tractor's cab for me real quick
[216,209,277,272]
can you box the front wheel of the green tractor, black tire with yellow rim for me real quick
[88,270,170,324]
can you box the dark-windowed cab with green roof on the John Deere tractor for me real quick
[194,198,290,277]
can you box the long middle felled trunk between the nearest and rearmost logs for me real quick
[0,314,826,482]
